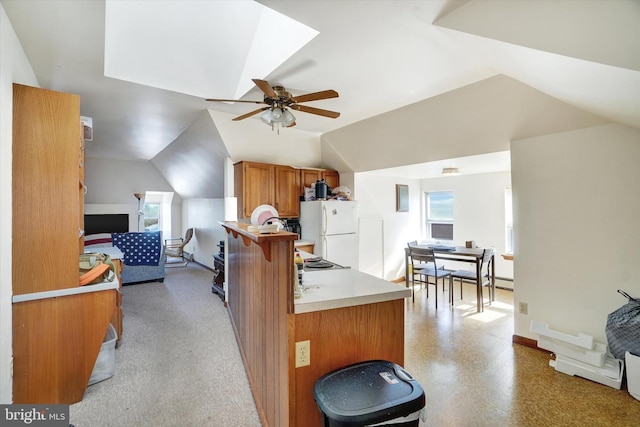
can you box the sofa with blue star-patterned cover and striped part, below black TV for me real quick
[85,231,166,285]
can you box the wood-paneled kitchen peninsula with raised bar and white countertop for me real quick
[221,222,410,427]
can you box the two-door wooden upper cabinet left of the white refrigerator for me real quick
[234,161,300,218]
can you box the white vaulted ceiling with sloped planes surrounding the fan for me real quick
[2,0,640,197]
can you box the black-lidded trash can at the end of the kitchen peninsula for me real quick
[313,360,425,427]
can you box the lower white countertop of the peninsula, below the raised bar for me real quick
[294,268,411,314]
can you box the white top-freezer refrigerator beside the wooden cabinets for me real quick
[300,200,359,269]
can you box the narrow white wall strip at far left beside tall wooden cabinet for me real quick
[0,4,39,404]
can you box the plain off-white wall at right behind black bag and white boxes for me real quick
[511,125,640,342]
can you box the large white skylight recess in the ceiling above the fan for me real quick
[104,0,318,99]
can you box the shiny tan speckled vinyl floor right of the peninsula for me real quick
[405,285,640,427]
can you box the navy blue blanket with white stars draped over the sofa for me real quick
[111,231,162,265]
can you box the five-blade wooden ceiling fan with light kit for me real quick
[206,79,340,127]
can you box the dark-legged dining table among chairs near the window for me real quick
[404,244,496,312]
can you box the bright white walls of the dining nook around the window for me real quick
[356,172,513,280]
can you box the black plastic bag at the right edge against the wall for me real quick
[605,290,640,360]
